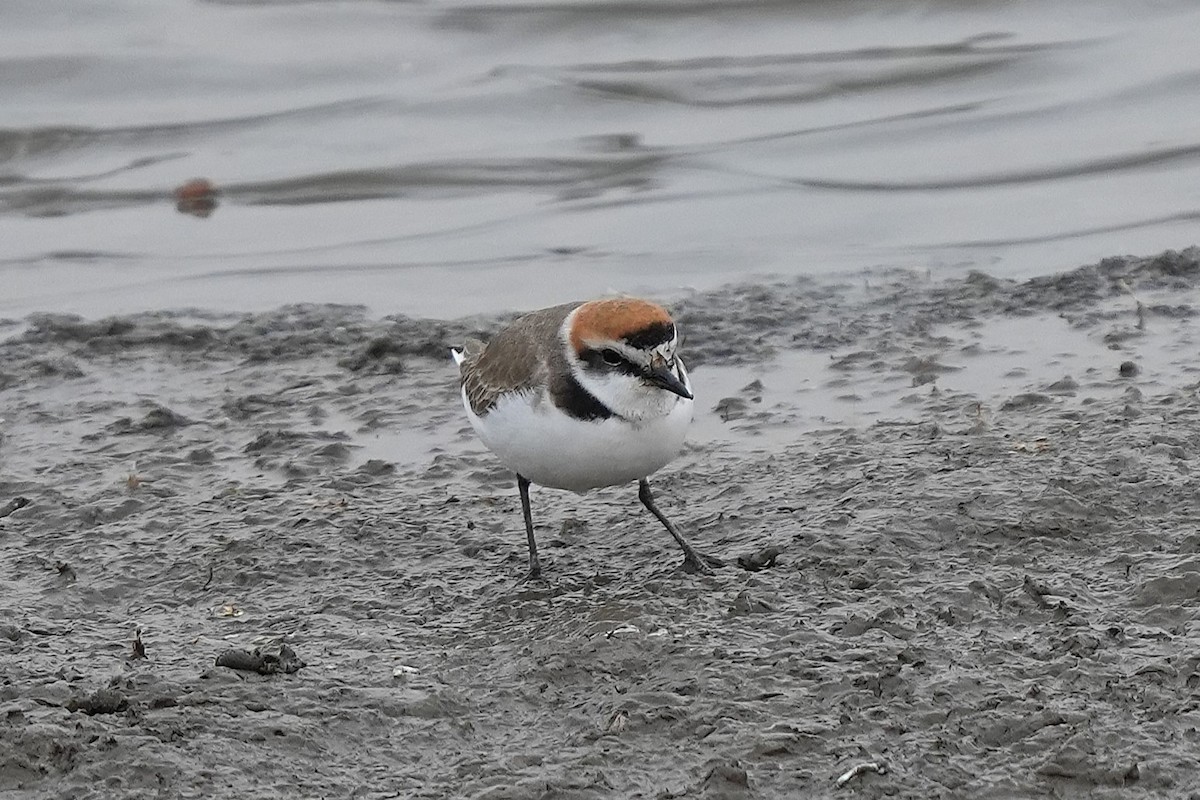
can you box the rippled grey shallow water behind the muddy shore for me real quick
[0,0,1200,318]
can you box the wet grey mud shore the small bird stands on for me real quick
[0,248,1200,800]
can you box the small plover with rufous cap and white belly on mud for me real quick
[450,296,724,579]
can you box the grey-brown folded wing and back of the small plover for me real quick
[460,302,580,416]
